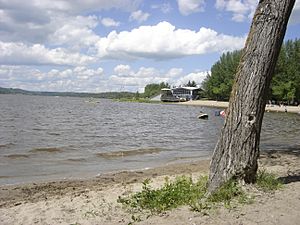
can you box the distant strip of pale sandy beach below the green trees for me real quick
[178,100,300,114]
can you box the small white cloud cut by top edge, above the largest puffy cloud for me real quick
[177,0,205,16]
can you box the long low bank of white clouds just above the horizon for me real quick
[0,64,211,92]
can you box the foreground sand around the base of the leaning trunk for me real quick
[0,149,300,225]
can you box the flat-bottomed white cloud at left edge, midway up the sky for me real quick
[0,41,95,66]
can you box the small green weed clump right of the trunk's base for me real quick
[256,170,282,192]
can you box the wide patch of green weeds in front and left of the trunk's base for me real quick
[118,176,250,214]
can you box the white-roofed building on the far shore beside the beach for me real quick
[160,87,201,102]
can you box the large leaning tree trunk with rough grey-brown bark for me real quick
[208,0,295,192]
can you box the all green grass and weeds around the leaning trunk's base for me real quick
[118,170,282,223]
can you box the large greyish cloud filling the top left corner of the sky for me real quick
[0,0,142,44]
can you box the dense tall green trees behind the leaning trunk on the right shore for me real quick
[202,39,300,104]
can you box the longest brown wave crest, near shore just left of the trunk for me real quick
[96,148,166,159]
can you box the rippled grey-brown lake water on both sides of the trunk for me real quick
[0,95,300,184]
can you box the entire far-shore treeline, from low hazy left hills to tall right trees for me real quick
[0,39,300,105]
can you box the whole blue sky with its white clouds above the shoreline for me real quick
[0,0,300,92]
